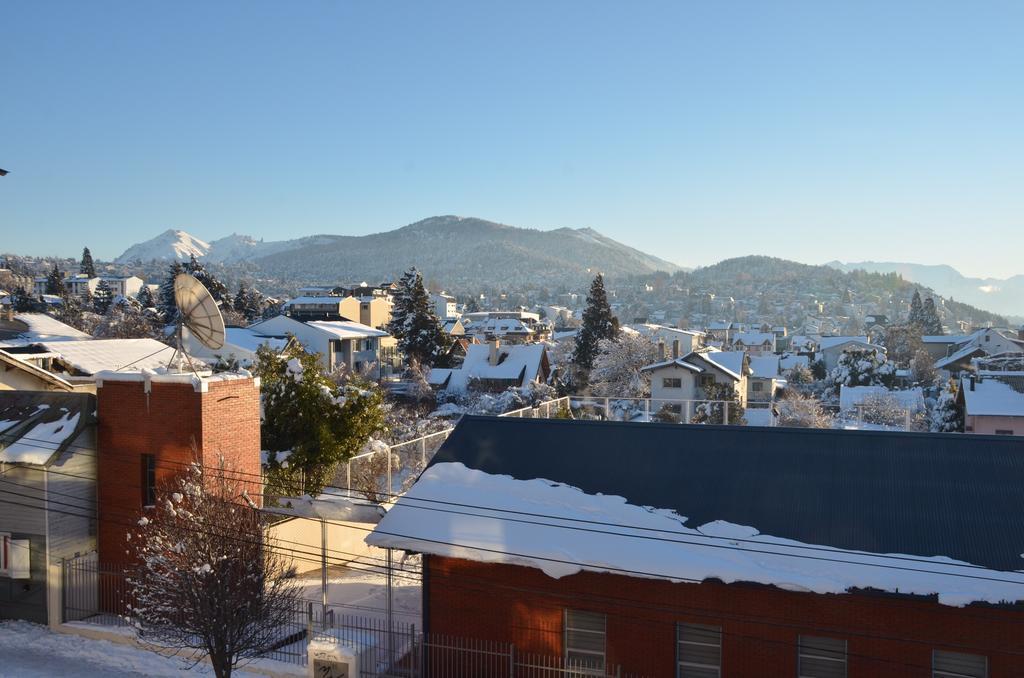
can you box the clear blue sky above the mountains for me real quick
[0,0,1024,277]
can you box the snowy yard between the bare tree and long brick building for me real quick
[286,552,423,626]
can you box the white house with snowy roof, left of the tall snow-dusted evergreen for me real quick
[249,315,389,372]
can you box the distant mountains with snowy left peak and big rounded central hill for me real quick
[115,216,680,285]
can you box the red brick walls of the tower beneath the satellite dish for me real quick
[96,379,260,563]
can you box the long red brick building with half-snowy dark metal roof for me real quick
[368,417,1024,678]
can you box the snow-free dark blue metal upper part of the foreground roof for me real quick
[431,416,1024,570]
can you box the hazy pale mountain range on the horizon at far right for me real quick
[825,261,1024,317]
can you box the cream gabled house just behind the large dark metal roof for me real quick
[642,349,752,415]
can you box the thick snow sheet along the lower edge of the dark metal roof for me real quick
[366,462,1024,605]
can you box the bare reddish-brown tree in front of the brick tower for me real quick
[128,464,298,678]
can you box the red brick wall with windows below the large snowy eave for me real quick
[424,556,1024,678]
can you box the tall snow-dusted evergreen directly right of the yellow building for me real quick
[387,267,452,366]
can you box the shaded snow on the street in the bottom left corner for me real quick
[0,622,276,678]
